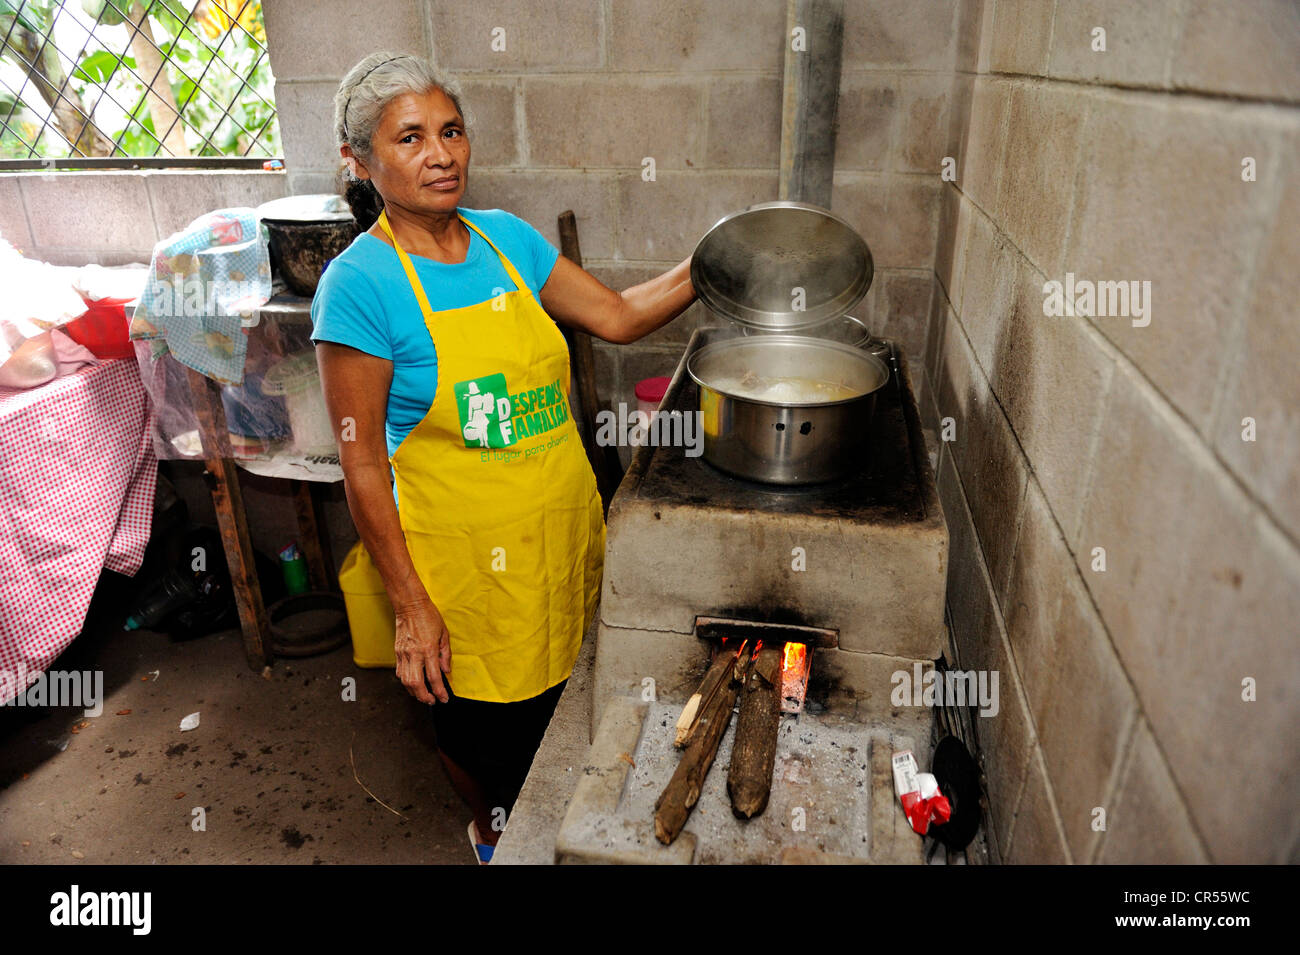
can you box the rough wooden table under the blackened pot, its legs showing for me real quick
[186,292,338,670]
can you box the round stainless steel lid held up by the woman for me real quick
[690,200,874,331]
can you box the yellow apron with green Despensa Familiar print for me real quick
[380,214,605,703]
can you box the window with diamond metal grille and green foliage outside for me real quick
[0,0,281,169]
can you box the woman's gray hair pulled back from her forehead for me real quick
[334,53,471,162]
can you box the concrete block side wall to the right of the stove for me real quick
[923,0,1300,863]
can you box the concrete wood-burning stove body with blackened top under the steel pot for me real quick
[556,330,948,861]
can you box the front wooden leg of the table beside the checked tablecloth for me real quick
[185,368,270,670]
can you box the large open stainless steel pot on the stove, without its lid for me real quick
[686,335,889,485]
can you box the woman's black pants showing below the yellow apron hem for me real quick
[430,680,568,816]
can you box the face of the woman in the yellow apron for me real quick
[356,90,469,213]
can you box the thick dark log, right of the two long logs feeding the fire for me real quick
[727,646,783,819]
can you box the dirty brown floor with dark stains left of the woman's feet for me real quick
[0,573,473,864]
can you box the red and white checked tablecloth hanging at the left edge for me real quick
[0,360,157,703]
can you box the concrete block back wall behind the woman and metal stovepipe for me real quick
[264,0,957,470]
